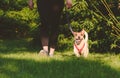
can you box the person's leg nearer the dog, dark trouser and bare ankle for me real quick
[49,0,64,56]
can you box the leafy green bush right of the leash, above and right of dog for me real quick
[61,0,120,53]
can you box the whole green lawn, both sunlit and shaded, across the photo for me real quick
[0,40,120,78]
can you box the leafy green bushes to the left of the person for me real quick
[0,0,38,38]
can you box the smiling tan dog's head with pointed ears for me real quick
[73,29,85,44]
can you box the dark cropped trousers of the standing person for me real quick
[37,0,64,46]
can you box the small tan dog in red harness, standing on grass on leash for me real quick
[72,29,89,57]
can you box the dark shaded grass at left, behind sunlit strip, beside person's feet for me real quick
[0,39,40,54]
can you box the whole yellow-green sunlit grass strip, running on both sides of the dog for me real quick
[0,51,120,71]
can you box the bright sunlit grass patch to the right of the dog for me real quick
[87,53,120,71]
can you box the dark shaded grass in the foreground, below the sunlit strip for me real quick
[0,57,120,78]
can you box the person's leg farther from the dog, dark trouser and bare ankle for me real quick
[37,0,49,52]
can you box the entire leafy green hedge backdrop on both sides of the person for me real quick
[0,0,120,53]
